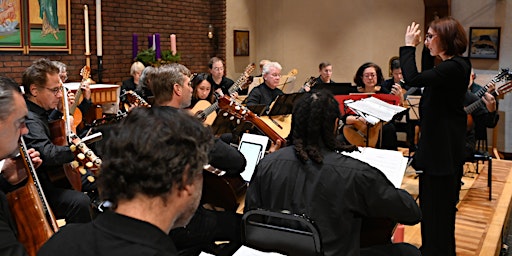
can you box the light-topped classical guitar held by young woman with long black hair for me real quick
[190,63,256,125]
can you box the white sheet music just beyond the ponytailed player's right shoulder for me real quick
[342,147,407,188]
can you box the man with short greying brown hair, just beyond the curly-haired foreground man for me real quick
[150,64,246,255]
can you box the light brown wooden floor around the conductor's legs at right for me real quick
[402,159,512,256]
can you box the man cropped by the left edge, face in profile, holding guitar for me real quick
[0,77,42,256]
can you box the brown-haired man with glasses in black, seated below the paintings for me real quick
[22,58,95,223]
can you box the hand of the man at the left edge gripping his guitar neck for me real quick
[2,148,43,185]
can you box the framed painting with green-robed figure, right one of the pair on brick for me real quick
[27,0,71,53]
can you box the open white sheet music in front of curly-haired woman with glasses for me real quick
[346,97,405,122]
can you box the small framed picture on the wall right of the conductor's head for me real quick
[468,27,501,59]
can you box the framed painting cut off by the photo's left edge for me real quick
[0,0,24,51]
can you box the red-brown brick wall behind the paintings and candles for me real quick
[0,0,226,83]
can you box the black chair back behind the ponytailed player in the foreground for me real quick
[242,209,323,256]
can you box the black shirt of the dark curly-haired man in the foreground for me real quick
[37,211,178,256]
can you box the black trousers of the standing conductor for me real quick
[419,172,460,256]
